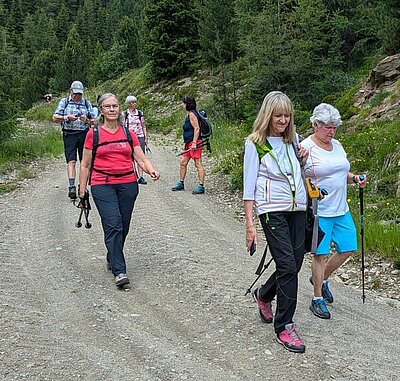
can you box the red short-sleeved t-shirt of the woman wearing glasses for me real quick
[84,126,140,185]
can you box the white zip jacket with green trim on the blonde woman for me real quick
[243,138,307,215]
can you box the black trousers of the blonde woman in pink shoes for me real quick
[259,212,306,334]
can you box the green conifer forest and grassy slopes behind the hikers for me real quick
[0,0,400,267]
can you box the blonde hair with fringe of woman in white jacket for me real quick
[248,91,295,144]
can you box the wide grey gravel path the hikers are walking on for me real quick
[0,141,400,381]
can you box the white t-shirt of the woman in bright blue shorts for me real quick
[301,137,350,217]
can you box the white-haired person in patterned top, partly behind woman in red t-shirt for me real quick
[123,95,148,185]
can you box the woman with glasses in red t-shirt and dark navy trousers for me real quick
[79,93,160,286]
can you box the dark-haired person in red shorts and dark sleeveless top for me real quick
[172,95,205,194]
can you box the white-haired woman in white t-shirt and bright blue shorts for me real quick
[301,103,367,319]
